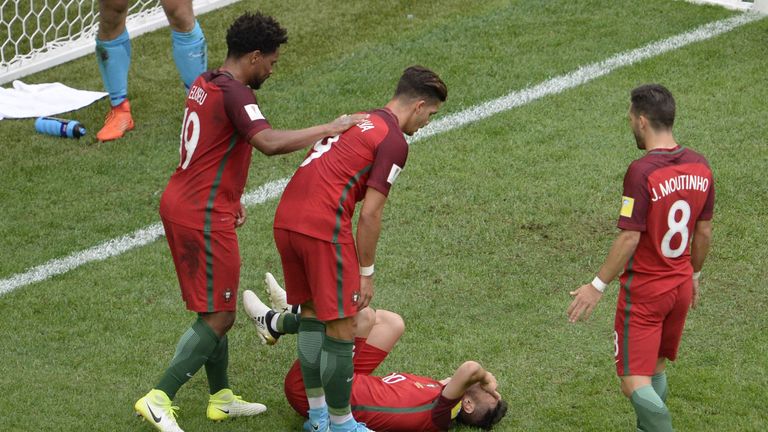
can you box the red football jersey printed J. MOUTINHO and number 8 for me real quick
[618,147,715,303]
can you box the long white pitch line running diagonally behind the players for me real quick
[0,13,764,296]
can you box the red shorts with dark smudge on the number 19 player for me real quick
[163,219,240,312]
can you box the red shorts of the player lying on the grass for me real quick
[283,338,388,417]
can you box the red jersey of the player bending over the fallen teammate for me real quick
[275,108,408,243]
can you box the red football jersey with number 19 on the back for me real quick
[160,70,270,231]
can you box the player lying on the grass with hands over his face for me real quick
[243,273,507,432]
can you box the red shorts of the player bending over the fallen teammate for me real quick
[274,228,360,321]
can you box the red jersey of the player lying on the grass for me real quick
[351,373,461,432]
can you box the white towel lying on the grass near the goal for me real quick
[0,80,107,120]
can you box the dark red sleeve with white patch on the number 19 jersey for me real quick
[222,80,271,141]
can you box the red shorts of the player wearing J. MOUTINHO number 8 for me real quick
[614,280,693,376]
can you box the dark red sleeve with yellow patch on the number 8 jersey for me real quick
[617,161,650,232]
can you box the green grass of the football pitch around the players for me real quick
[0,0,768,431]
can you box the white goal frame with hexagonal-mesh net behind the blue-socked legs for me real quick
[0,0,238,84]
